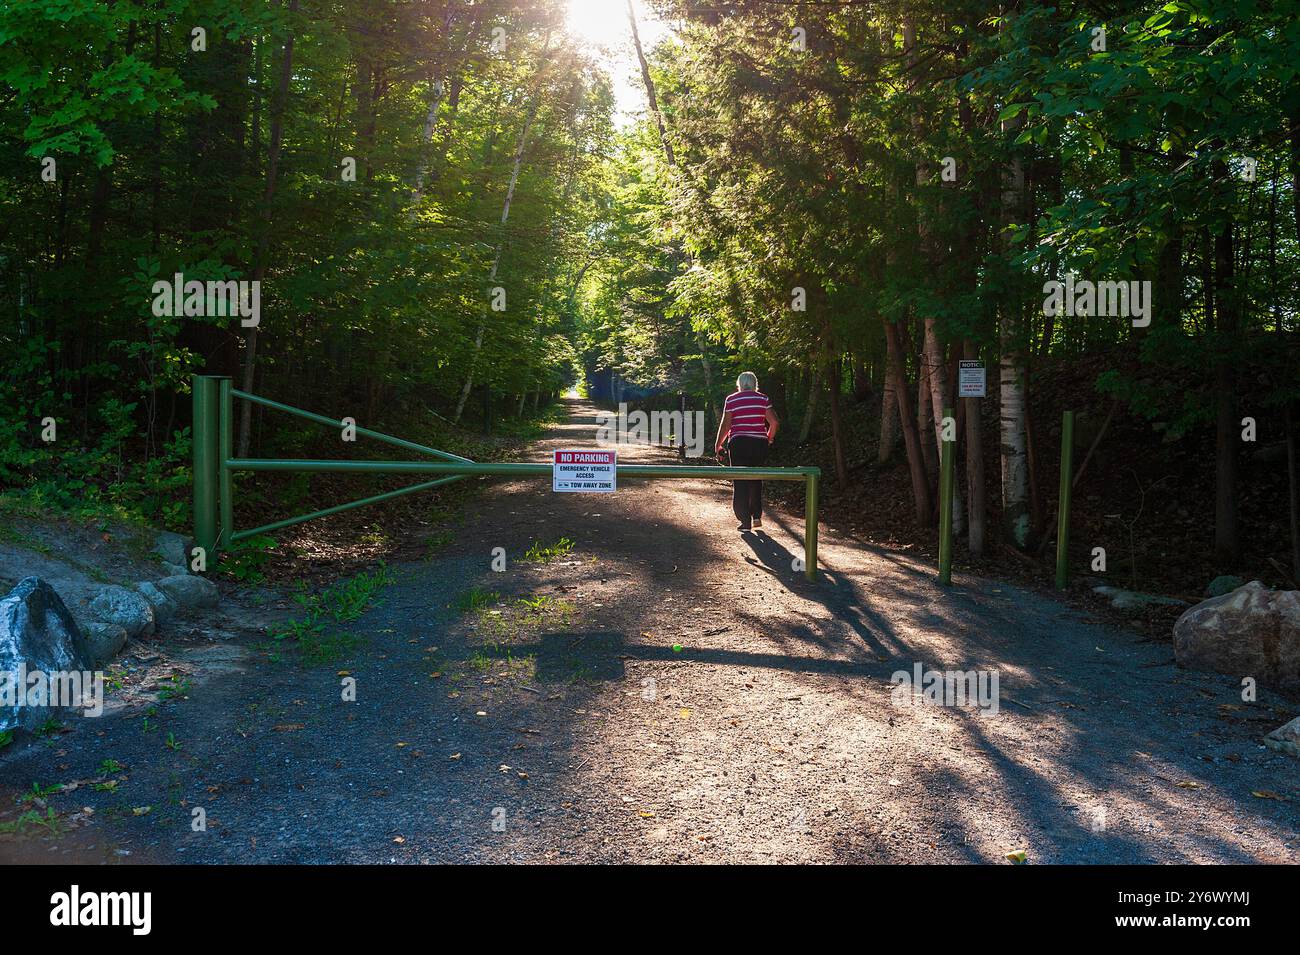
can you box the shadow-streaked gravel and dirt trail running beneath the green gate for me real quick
[0,401,1300,863]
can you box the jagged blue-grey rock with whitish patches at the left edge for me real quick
[0,577,92,732]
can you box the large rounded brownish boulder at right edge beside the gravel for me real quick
[1174,581,1300,693]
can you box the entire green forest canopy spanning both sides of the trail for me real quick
[0,0,1300,576]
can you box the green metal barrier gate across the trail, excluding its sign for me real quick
[192,374,822,581]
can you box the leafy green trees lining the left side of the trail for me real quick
[0,0,595,522]
